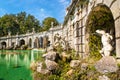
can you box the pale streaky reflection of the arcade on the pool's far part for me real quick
[0,50,42,67]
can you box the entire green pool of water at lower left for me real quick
[0,50,42,80]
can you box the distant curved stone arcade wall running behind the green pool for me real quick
[0,26,62,48]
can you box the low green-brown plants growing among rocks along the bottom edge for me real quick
[34,49,120,80]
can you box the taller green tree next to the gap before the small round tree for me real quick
[17,12,41,34]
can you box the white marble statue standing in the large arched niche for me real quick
[96,30,113,56]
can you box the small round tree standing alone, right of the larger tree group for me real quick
[42,17,59,31]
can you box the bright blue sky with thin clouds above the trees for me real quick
[0,0,71,23]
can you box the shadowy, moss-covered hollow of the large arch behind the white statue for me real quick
[85,4,115,57]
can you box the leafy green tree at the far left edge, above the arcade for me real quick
[0,14,19,36]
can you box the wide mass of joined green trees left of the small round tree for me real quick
[0,12,41,36]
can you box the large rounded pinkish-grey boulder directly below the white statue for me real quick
[95,56,118,73]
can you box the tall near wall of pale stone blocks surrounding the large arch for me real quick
[63,0,120,58]
